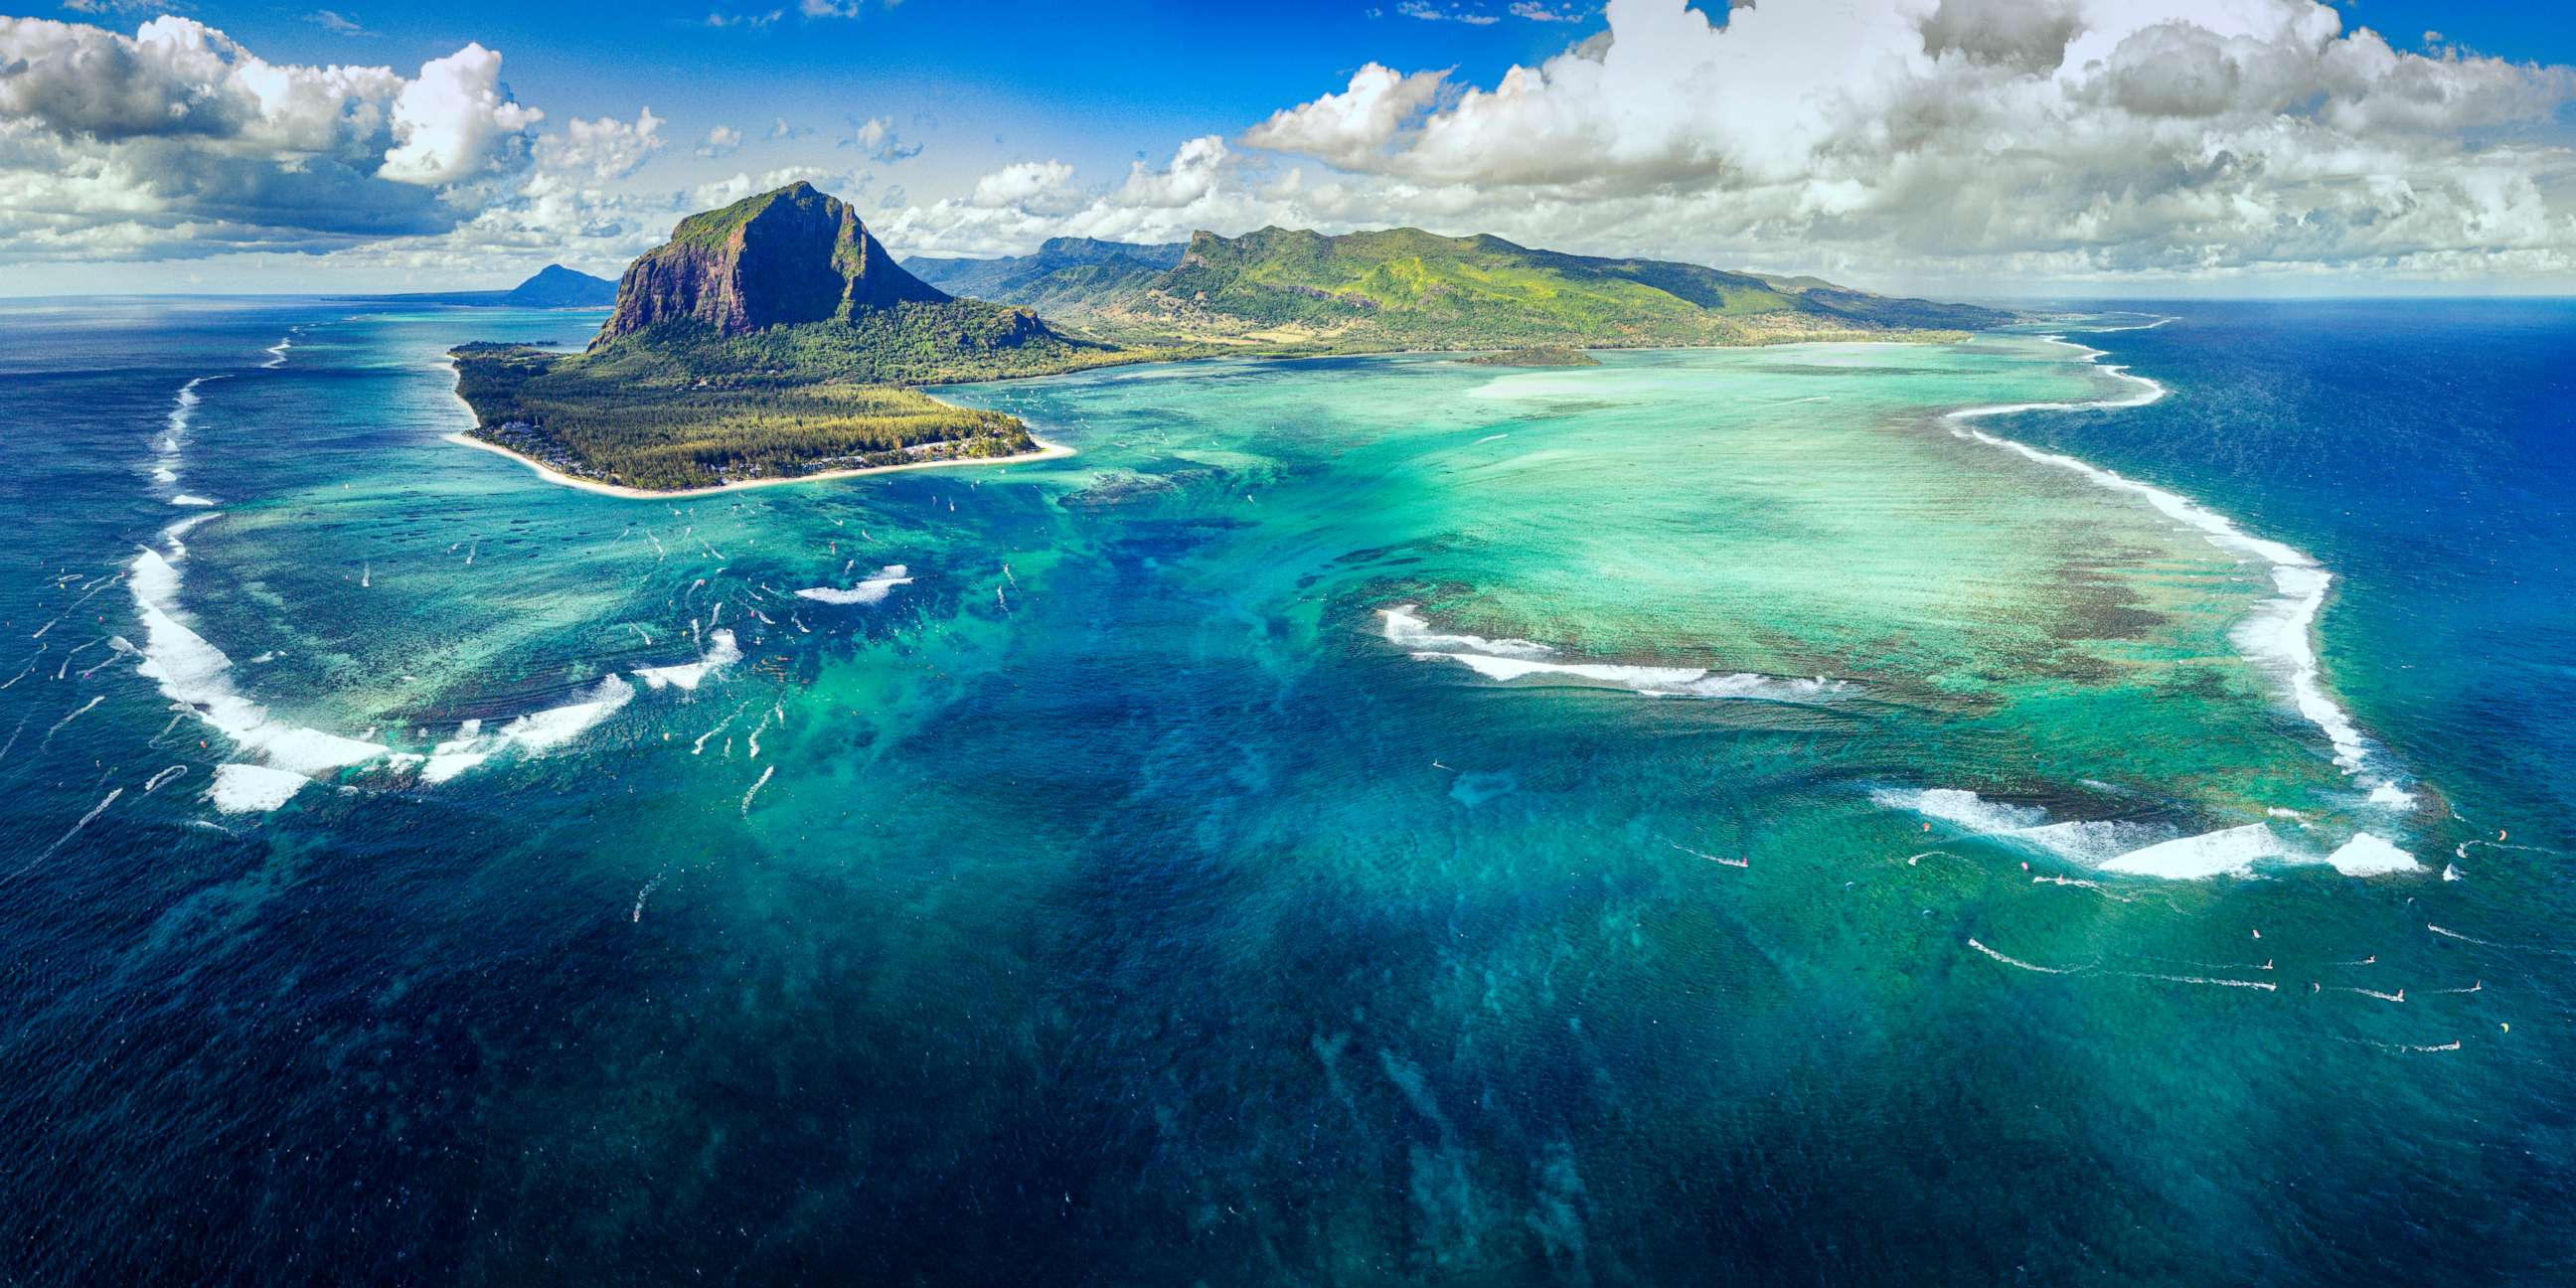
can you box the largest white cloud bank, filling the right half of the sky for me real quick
[1244,0,2576,278]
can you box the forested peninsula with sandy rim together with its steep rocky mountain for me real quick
[451,183,1152,492]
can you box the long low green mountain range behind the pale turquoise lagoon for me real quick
[935,227,2012,351]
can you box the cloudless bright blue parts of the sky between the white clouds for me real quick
[171,0,2576,189]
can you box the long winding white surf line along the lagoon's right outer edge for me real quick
[1945,335,2414,824]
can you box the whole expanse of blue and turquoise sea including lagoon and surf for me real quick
[0,299,2576,1283]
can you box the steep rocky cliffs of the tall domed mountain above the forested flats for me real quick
[592,183,948,348]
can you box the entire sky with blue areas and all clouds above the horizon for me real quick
[0,0,2576,293]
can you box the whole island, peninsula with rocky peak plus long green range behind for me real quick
[448,183,2012,495]
